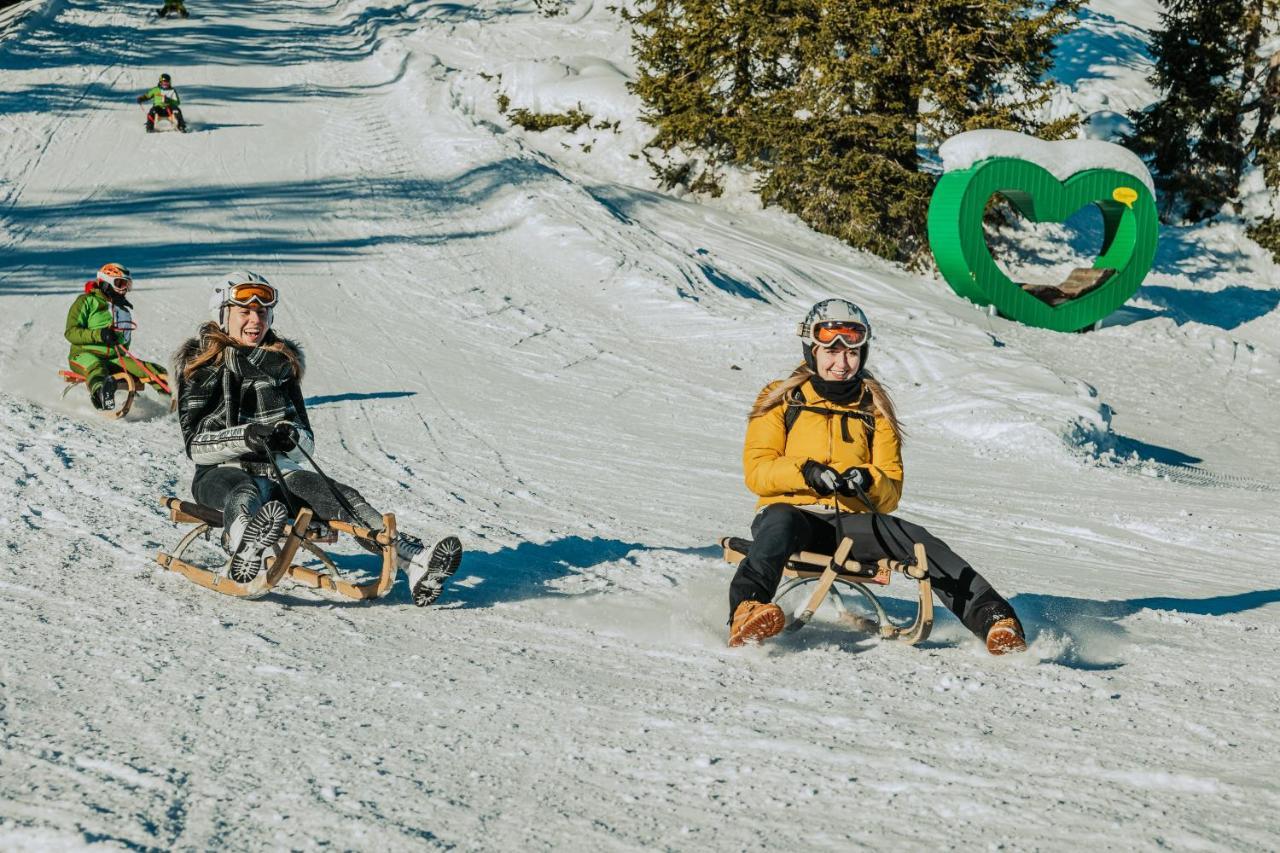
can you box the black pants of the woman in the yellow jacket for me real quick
[728,503,1015,638]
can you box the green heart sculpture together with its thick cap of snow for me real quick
[928,131,1158,332]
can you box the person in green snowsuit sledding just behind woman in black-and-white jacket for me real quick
[64,264,169,411]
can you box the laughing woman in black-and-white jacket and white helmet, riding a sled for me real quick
[174,272,462,596]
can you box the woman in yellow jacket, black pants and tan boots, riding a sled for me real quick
[730,300,1027,654]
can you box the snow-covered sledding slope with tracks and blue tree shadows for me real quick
[0,0,1280,850]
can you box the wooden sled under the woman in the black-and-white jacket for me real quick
[156,497,396,599]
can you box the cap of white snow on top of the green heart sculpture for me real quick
[938,131,1156,195]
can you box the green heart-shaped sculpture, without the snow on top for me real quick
[928,156,1158,332]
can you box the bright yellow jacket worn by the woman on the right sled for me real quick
[742,382,902,512]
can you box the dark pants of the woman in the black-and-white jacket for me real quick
[191,465,383,551]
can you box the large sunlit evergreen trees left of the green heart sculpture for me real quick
[627,0,1082,261]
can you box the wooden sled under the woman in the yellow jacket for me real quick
[721,537,933,646]
